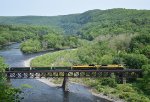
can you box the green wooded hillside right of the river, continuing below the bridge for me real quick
[28,9,150,102]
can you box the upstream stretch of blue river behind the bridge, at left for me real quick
[0,43,50,67]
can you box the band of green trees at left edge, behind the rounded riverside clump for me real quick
[0,25,57,46]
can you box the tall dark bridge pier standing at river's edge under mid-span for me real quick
[62,72,69,92]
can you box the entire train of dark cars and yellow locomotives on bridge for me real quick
[7,64,124,71]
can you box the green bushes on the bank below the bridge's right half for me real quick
[79,78,150,102]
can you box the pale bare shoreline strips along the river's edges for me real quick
[24,54,124,102]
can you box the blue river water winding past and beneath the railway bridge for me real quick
[0,44,110,102]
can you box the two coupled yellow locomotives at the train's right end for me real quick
[72,64,124,70]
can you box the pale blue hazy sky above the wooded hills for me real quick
[0,0,150,16]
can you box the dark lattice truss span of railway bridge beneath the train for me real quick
[5,69,142,79]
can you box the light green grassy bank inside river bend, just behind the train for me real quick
[31,49,78,67]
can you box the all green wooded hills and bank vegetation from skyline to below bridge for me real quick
[0,9,150,102]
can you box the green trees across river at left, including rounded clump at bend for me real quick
[0,25,80,53]
